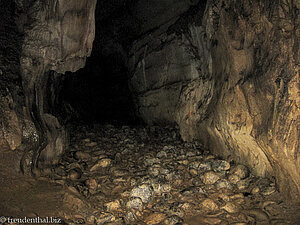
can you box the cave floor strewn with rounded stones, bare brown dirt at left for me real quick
[0,125,300,225]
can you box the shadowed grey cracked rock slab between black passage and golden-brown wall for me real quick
[129,1,214,125]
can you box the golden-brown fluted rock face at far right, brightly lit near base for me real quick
[201,1,300,199]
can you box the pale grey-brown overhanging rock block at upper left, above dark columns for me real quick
[22,0,96,73]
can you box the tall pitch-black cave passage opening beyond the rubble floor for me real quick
[59,0,141,125]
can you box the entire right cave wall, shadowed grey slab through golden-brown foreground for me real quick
[129,0,300,200]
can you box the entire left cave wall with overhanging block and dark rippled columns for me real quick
[0,0,96,172]
